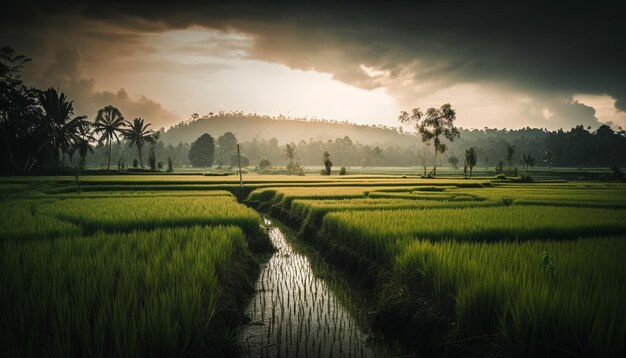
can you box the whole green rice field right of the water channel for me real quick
[246,178,626,357]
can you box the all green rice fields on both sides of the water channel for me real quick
[0,175,626,357]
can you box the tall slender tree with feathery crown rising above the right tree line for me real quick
[398,103,460,176]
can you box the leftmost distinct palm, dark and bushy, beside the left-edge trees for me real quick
[39,88,89,164]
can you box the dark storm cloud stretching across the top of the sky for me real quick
[3,0,626,126]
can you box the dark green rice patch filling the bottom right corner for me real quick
[396,236,626,357]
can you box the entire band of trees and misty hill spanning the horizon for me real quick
[0,47,626,174]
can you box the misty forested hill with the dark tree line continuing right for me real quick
[136,112,626,168]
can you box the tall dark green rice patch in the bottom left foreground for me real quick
[0,226,254,357]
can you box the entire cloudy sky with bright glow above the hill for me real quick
[0,0,626,130]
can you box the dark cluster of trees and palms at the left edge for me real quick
[0,47,159,173]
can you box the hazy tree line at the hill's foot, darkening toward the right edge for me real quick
[79,120,626,172]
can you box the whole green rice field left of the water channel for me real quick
[0,186,269,357]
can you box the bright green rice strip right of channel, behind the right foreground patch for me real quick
[322,206,626,259]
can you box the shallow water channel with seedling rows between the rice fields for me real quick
[239,219,376,357]
